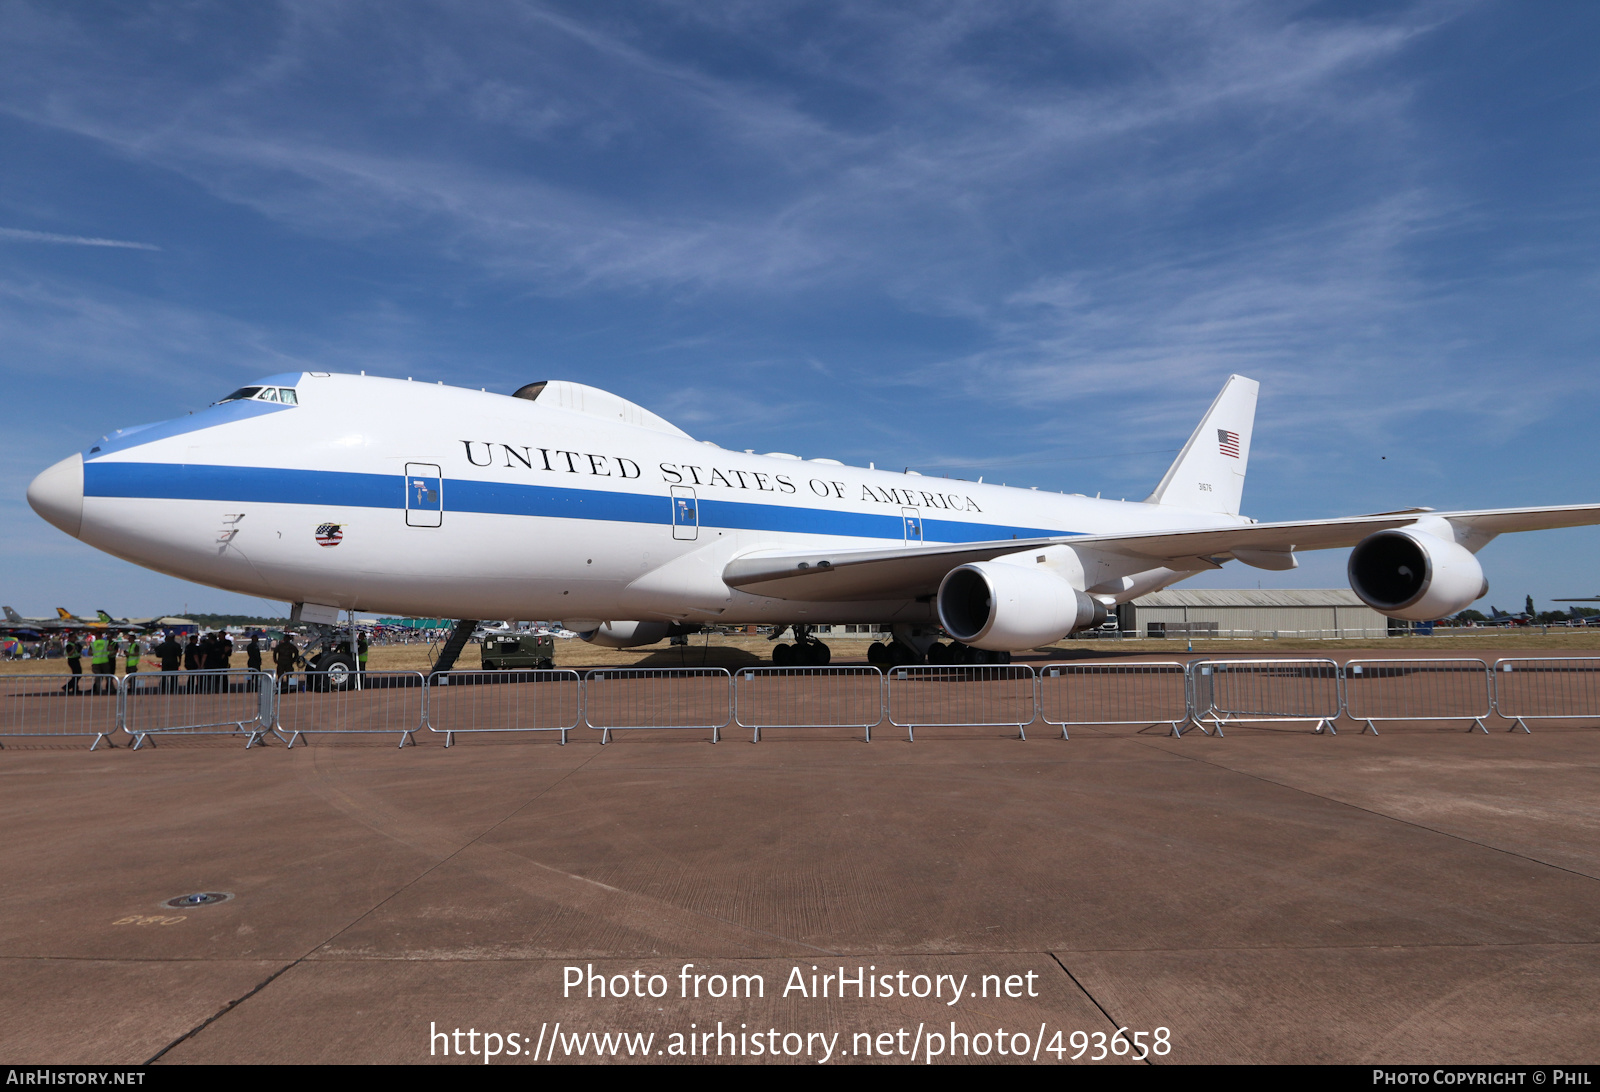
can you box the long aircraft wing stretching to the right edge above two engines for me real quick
[722,504,1600,602]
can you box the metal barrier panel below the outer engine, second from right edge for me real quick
[1344,658,1494,735]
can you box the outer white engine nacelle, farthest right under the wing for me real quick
[1349,527,1490,621]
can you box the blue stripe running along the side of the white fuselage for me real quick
[83,460,1082,543]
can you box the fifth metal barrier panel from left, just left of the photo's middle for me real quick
[584,668,733,743]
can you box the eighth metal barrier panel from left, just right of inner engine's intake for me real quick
[1038,661,1189,740]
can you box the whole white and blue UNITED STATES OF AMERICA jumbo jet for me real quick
[27,371,1600,666]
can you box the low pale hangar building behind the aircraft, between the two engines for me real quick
[1117,588,1389,637]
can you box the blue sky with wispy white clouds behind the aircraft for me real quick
[0,0,1600,615]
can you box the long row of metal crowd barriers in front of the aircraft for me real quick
[18,656,1600,749]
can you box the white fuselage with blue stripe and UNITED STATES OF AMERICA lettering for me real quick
[56,373,1248,623]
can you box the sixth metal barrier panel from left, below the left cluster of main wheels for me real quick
[733,668,883,743]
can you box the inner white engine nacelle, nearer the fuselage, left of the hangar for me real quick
[938,560,1106,652]
